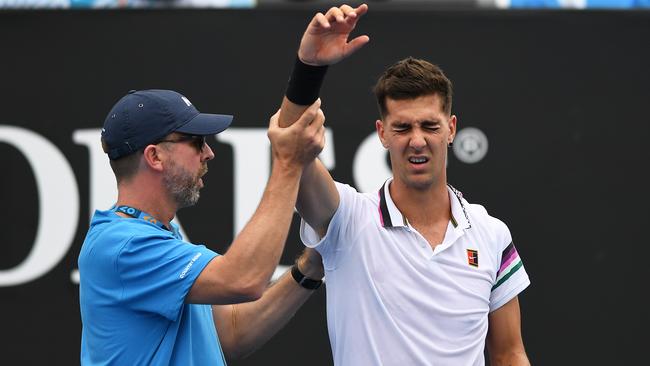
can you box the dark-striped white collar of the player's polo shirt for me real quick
[378,178,472,229]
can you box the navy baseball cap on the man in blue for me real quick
[102,89,233,160]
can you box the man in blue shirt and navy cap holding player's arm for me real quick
[79,90,324,366]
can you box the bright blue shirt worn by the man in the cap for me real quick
[79,210,226,366]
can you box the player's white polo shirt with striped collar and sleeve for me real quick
[300,180,530,366]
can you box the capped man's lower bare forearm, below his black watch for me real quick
[215,272,315,359]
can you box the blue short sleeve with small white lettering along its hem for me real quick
[116,234,218,321]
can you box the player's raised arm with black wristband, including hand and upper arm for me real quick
[279,4,370,235]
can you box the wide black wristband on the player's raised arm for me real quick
[285,57,327,105]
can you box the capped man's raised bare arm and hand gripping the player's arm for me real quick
[186,101,325,304]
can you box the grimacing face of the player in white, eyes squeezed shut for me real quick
[376,94,456,190]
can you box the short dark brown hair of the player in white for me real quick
[373,57,453,118]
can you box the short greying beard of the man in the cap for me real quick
[163,161,208,209]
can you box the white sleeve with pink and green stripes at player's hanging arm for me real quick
[490,222,530,312]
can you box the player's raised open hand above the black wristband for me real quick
[298,4,370,66]
